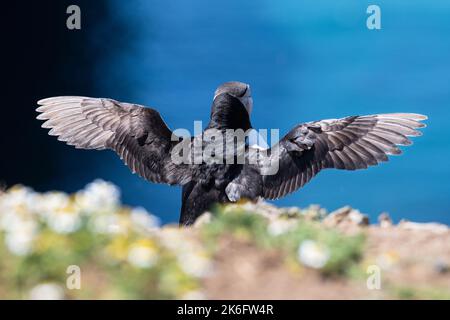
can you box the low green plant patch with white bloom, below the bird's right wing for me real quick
[203,202,365,275]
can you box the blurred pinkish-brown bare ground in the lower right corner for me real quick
[204,222,450,299]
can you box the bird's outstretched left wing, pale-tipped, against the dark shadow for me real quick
[37,96,190,184]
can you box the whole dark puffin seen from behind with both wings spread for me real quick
[37,82,427,225]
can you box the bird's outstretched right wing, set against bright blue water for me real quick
[262,113,427,199]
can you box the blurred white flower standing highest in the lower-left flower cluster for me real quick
[76,179,120,212]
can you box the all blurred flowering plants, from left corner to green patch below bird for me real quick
[0,180,364,299]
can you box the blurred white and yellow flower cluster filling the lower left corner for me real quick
[0,180,212,299]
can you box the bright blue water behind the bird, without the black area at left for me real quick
[54,0,450,224]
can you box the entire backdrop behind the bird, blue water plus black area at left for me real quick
[0,0,450,224]
